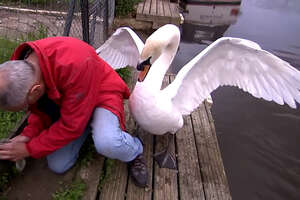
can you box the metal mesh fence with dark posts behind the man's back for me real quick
[0,0,115,63]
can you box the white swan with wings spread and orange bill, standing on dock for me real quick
[97,24,300,168]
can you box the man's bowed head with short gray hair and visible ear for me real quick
[0,60,45,111]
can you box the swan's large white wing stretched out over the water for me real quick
[162,38,300,114]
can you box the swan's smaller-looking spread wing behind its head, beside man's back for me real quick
[96,27,144,69]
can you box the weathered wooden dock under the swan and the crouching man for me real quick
[0,75,231,200]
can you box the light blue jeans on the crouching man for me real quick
[47,108,143,173]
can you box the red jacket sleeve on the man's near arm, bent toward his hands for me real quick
[27,59,95,158]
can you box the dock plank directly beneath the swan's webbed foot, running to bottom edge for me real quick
[154,76,178,200]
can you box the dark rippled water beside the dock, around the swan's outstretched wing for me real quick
[172,0,300,200]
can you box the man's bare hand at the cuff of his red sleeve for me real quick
[0,141,29,161]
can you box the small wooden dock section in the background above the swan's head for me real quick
[136,0,181,29]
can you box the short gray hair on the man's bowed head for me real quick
[0,60,35,109]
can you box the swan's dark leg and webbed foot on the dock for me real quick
[154,133,177,170]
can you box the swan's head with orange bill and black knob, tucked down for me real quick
[137,24,180,81]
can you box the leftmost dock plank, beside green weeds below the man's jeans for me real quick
[77,154,104,200]
